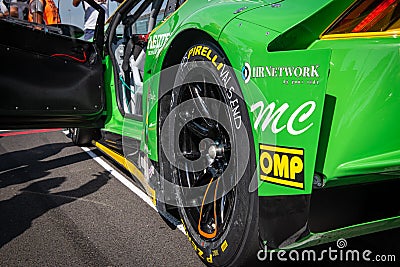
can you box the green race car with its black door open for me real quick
[0,0,400,266]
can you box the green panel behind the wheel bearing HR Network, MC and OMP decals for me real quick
[220,20,331,196]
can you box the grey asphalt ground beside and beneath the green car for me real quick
[0,131,400,266]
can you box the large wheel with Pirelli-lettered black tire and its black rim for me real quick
[169,41,259,266]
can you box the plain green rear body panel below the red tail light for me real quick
[312,37,400,185]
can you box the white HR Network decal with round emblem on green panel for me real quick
[242,62,320,85]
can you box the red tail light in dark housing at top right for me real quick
[325,0,400,35]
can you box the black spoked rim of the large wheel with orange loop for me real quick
[177,70,236,241]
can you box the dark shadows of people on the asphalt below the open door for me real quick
[0,143,110,248]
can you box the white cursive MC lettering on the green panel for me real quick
[250,101,316,135]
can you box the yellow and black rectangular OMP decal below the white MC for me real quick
[260,144,304,189]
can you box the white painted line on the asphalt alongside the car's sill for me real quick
[81,147,185,234]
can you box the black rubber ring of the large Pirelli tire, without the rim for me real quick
[171,41,258,266]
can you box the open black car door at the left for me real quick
[0,0,105,129]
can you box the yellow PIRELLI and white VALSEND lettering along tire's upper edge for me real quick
[181,45,242,129]
